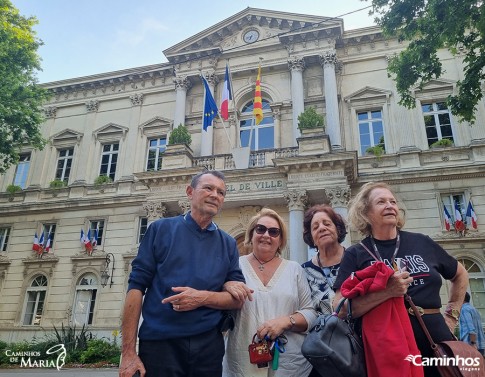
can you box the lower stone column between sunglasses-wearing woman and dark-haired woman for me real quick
[283,190,308,263]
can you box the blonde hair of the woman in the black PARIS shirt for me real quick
[348,182,405,236]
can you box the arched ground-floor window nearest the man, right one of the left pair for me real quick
[72,273,98,326]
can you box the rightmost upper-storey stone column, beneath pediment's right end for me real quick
[320,51,342,149]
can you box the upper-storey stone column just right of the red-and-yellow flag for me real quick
[288,56,305,147]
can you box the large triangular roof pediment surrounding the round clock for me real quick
[163,7,343,63]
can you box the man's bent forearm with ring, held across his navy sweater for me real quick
[162,287,249,312]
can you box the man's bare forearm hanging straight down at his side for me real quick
[119,289,146,377]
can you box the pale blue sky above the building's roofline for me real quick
[11,0,374,83]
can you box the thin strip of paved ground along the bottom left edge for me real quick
[0,368,118,377]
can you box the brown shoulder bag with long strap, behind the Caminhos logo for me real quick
[405,295,485,377]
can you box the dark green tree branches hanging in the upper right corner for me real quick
[371,0,485,123]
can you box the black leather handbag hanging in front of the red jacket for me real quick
[301,299,367,377]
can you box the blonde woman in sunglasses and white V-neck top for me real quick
[224,208,316,377]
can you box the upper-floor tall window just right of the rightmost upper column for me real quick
[357,110,384,155]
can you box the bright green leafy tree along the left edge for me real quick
[0,0,48,173]
